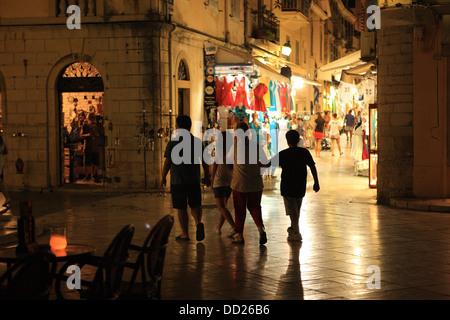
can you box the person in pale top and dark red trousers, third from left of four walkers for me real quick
[231,122,267,245]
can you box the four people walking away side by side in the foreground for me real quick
[160,115,320,245]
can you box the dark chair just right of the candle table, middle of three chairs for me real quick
[55,225,134,300]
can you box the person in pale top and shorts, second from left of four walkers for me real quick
[211,131,236,237]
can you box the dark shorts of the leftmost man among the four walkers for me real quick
[170,183,202,210]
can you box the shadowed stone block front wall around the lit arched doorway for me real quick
[0,23,170,188]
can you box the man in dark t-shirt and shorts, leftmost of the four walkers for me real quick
[160,115,210,241]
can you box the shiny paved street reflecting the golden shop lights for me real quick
[0,141,450,300]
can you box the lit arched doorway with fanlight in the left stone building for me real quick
[57,61,106,185]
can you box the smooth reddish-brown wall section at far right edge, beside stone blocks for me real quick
[413,19,450,198]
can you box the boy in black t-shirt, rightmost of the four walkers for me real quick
[271,130,320,241]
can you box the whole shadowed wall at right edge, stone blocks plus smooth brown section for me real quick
[377,4,450,203]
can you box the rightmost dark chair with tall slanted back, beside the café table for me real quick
[121,215,174,300]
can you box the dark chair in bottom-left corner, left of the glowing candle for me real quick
[0,253,56,300]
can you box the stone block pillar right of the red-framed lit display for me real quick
[377,25,414,202]
